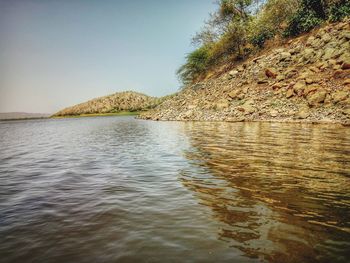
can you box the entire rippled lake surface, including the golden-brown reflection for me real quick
[0,117,350,262]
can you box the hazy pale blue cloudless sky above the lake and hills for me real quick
[0,0,216,113]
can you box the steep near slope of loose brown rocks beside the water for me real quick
[141,20,350,123]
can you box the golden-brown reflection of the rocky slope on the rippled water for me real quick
[180,123,350,262]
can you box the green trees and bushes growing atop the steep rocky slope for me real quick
[177,0,350,84]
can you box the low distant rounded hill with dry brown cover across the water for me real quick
[54,91,162,116]
